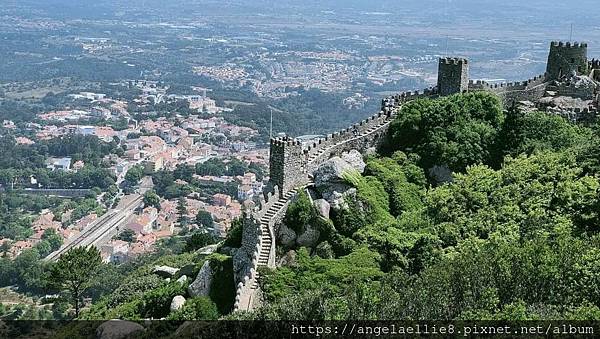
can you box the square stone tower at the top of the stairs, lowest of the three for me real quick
[269,137,308,194]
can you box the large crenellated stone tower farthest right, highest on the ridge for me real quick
[546,41,588,80]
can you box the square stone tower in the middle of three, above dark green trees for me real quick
[438,58,469,96]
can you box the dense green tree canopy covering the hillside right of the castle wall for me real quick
[248,93,600,320]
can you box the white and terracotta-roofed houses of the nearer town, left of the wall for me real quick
[0,81,268,262]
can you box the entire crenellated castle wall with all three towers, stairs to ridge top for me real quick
[234,41,600,310]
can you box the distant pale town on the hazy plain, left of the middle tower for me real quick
[193,47,438,101]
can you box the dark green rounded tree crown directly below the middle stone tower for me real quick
[385,92,504,171]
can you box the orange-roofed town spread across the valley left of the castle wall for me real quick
[0,81,268,262]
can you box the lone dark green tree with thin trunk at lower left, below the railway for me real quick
[50,246,102,318]
